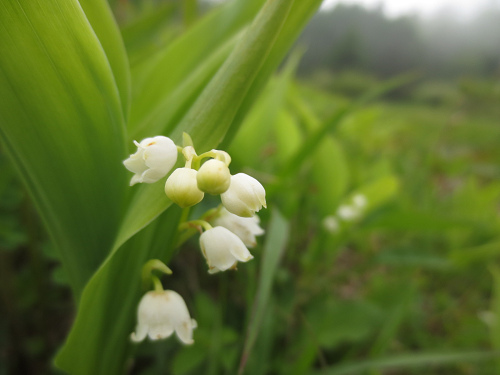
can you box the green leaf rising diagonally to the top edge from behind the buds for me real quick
[173,0,293,148]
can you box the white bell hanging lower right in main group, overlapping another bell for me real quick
[200,227,253,273]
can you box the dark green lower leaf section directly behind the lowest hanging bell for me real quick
[55,207,181,375]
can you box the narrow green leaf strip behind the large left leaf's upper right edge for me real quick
[80,0,130,118]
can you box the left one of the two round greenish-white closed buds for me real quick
[165,168,205,208]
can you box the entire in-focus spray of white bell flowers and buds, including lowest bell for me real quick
[123,134,266,344]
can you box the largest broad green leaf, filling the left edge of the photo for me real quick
[0,0,126,299]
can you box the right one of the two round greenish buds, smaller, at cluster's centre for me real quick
[196,159,231,195]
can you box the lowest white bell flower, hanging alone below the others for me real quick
[130,290,197,345]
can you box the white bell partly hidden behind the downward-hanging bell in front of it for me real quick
[213,208,264,247]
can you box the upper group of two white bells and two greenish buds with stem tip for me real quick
[123,135,266,217]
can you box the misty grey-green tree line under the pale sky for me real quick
[299,3,500,79]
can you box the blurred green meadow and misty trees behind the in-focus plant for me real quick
[0,0,500,375]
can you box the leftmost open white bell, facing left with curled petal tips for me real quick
[123,135,177,186]
